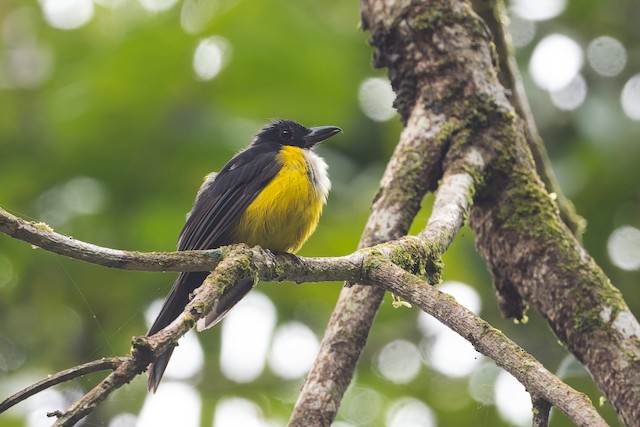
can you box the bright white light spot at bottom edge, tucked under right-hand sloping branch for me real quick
[495,371,532,426]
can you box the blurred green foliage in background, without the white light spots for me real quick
[0,0,640,426]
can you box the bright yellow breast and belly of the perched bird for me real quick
[233,146,328,252]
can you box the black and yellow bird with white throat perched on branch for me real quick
[147,119,342,392]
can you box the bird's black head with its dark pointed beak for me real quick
[253,119,342,148]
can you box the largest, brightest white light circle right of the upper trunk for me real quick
[529,34,584,91]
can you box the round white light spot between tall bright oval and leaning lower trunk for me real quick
[269,322,320,379]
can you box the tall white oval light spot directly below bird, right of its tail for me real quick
[220,290,276,383]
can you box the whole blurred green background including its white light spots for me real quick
[0,0,640,427]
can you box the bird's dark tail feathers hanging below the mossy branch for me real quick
[147,272,254,392]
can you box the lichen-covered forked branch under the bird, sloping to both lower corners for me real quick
[1,201,606,426]
